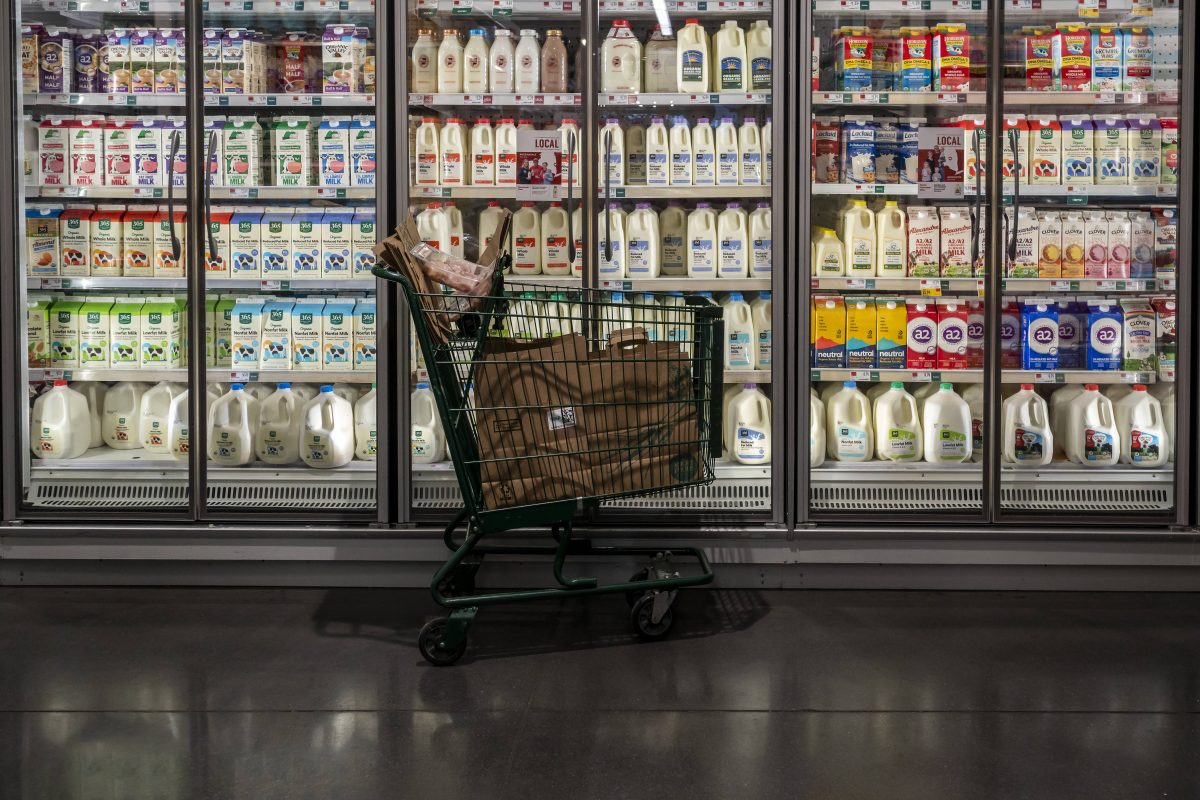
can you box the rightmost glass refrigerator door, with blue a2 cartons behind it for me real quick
[996,0,1180,523]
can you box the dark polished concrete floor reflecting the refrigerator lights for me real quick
[0,589,1200,800]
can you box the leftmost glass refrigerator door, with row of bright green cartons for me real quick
[13,0,196,513]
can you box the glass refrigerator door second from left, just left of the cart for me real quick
[200,0,378,516]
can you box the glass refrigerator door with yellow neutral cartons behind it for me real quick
[799,0,990,521]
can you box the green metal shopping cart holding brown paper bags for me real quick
[374,261,724,664]
